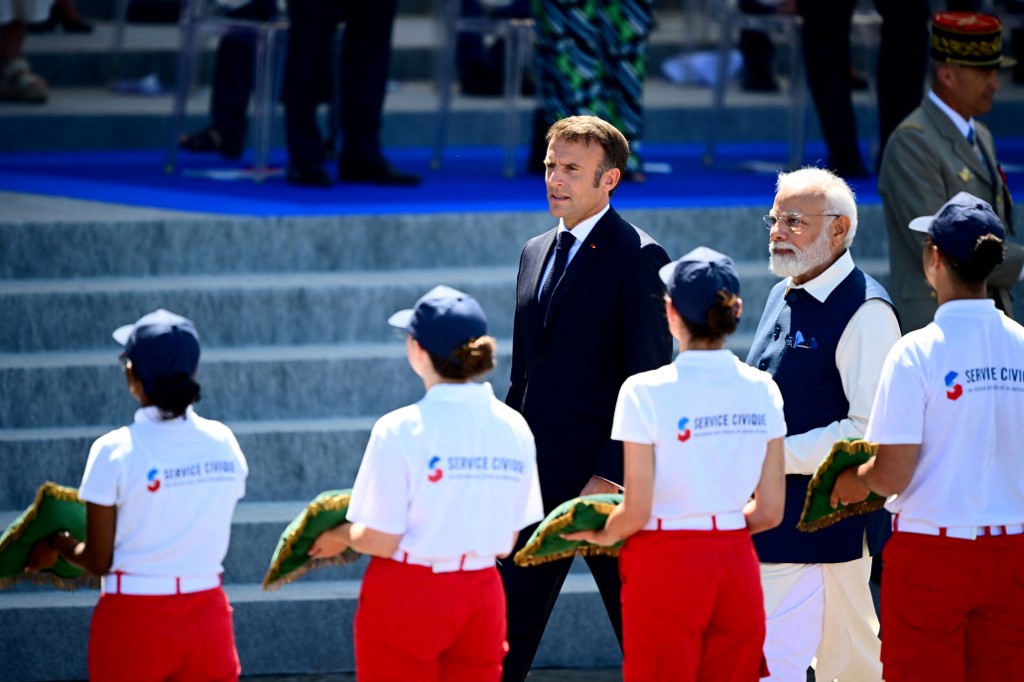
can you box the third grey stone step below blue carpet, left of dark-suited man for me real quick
[0,340,511,429]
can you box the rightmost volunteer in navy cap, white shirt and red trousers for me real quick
[831,193,1024,682]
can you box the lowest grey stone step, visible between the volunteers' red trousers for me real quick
[0,573,622,682]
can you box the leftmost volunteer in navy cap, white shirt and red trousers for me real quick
[30,309,249,682]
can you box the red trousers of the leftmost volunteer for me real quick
[89,588,242,682]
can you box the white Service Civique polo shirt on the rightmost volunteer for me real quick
[865,300,1024,527]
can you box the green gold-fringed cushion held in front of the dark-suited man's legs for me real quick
[515,493,623,566]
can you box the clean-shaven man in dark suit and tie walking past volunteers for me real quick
[501,116,672,680]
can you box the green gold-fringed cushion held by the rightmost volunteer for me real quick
[797,438,886,532]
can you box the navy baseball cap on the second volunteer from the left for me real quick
[387,285,487,359]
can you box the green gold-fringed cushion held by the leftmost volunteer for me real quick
[0,481,99,590]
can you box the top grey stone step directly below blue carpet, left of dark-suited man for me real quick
[0,209,544,278]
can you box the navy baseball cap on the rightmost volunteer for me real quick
[908,191,1007,260]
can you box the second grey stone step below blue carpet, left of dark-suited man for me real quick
[0,266,516,353]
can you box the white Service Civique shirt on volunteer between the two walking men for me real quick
[611,350,785,519]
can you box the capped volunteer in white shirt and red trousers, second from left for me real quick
[309,287,544,682]
